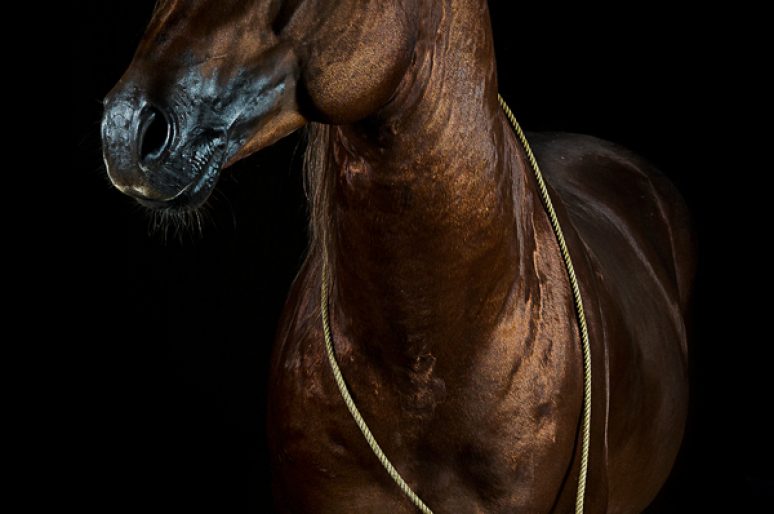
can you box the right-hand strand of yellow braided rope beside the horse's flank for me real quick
[497,94,591,514]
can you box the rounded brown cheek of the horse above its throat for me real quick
[283,0,417,124]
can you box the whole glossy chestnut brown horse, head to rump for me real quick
[102,0,693,514]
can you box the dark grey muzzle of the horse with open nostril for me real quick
[102,46,306,209]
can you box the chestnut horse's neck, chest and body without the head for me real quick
[270,3,690,512]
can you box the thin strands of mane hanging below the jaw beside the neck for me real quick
[303,122,336,277]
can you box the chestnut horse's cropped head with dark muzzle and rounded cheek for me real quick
[102,0,416,210]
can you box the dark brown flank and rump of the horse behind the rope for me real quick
[532,134,693,512]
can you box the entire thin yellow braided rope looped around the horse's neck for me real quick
[320,95,591,508]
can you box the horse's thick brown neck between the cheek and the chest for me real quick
[318,0,534,365]
